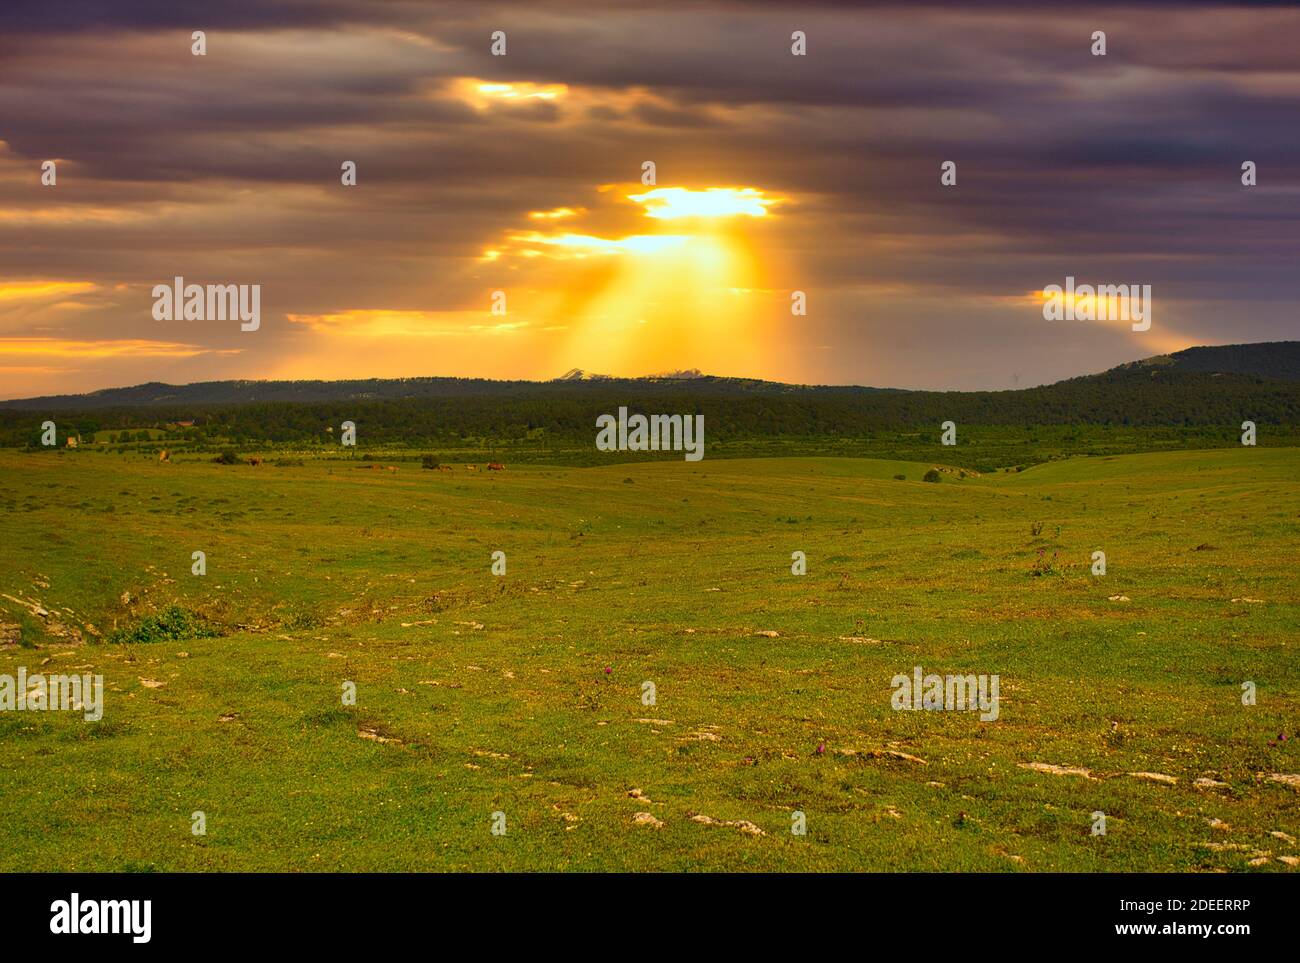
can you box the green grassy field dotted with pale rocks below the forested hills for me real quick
[0,446,1300,872]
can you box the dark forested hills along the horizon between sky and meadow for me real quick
[0,342,1300,449]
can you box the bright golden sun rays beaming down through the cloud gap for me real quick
[480,186,784,374]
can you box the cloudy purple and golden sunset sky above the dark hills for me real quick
[0,0,1300,398]
